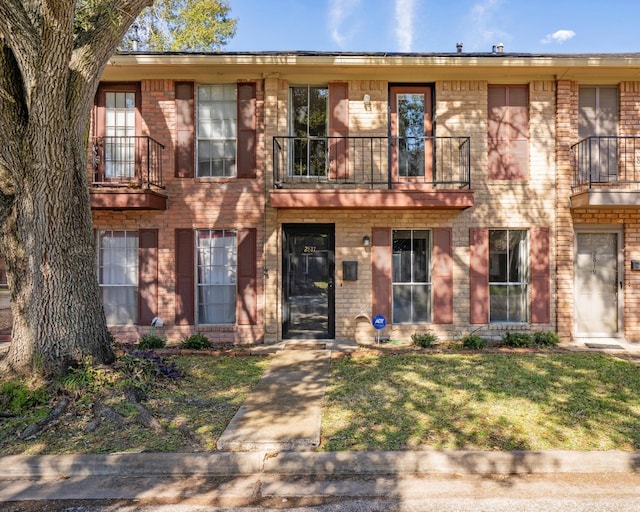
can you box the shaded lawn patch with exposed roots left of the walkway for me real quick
[0,350,269,455]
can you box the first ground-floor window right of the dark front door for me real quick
[392,229,431,324]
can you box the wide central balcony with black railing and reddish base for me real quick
[270,136,474,210]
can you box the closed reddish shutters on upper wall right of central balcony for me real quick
[487,85,529,180]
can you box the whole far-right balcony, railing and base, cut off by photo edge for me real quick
[571,136,640,208]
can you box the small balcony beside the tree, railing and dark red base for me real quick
[88,136,167,210]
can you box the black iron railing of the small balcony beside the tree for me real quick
[88,136,164,189]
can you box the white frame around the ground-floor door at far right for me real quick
[573,224,624,338]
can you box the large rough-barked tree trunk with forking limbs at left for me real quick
[0,0,152,376]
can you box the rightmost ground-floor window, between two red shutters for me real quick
[489,229,529,322]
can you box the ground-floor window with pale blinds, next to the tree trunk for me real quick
[97,231,138,325]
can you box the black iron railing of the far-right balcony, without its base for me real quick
[571,135,640,191]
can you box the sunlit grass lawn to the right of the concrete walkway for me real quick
[321,352,640,451]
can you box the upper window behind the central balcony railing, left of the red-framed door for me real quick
[289,86,329,178]
